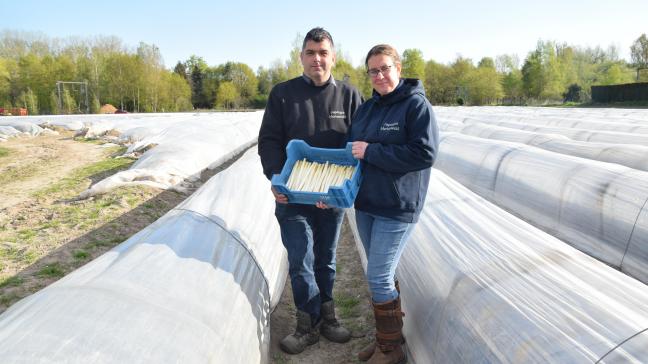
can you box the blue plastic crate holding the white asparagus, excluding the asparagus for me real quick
[272,139,362,208]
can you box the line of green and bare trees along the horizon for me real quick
[0,31,648,115]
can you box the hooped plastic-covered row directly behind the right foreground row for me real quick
[435,133,648,282]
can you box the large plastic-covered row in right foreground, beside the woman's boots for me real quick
[349,170,648,364]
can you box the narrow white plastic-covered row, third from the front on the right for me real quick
[440,120,648,171]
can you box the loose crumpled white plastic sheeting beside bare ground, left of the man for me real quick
[1,111,263,198]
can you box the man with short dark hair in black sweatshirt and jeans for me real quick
[258,28,362,354]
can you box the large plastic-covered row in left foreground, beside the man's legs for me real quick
[0,150,287,363]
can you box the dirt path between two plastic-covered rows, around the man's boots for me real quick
[270,219,374,364]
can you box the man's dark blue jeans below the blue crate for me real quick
[275,203,344,323]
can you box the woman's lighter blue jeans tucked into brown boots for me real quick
[355,210,415,303]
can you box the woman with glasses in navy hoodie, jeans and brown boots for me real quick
[349,44,438,363]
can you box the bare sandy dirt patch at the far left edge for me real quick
[0,132,106,211]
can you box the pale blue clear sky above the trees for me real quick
[0,0,648,70]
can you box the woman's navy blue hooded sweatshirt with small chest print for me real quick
[349,78,439,222]
